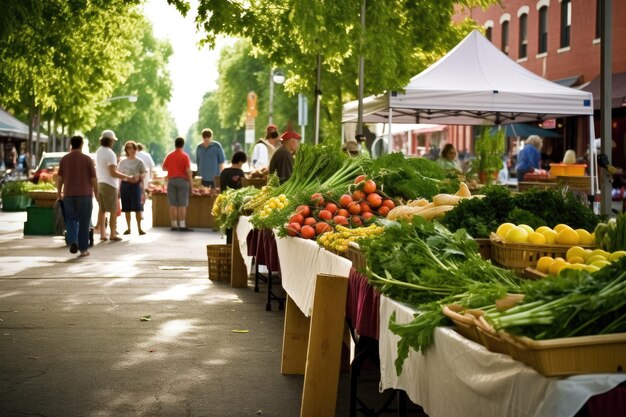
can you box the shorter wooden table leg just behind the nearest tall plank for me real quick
[281,296,310,375]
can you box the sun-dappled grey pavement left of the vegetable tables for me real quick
[0,200,308,417]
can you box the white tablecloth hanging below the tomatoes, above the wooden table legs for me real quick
[276,237,352,317]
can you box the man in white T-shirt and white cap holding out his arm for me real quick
[96,130,133,242]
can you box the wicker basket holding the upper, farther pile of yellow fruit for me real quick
[491,233,590,272]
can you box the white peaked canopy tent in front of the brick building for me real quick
[342,30,596,192]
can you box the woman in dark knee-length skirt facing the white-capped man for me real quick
[117,140,146,235]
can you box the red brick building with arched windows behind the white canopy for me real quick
[450,0,626,168]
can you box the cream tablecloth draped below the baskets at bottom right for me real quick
[379,296,626,417]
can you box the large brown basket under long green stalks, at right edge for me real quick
[503,333,626,376]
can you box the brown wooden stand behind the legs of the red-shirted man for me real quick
[152,194,217,228]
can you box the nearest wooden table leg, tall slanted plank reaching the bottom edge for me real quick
[300,274,348,417]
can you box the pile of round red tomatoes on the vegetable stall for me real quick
[287,175,395,239]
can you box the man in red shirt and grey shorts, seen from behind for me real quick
[163,137,193,232]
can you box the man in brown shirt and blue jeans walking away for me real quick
[57,136,98,256]
